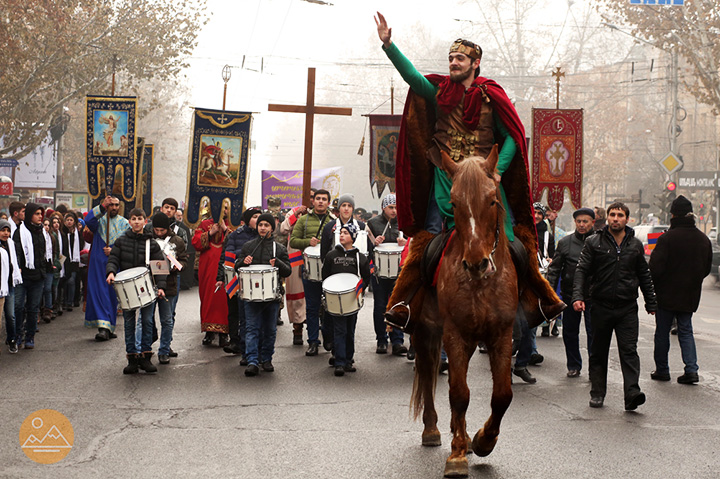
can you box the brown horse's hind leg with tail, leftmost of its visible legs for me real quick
[412,318,442,447]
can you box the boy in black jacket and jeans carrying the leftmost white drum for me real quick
[105,208,166,374]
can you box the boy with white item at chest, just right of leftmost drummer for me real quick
[152,211,187,364]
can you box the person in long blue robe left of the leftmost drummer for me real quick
[85,206,130,332]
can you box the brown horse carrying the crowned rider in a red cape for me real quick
[413,146,518,477]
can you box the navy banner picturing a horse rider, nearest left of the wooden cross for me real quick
[185,108,252,228]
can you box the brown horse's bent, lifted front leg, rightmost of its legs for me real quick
[472,326,512,456]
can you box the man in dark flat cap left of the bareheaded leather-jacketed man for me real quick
[547,208,595,378]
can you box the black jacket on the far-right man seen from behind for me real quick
[650,216,712,313]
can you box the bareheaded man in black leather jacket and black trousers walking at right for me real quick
[573,202,657,411]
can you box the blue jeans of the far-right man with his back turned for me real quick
[653,307,698,374]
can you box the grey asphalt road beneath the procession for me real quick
[0,283,720,479]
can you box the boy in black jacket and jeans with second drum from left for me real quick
[235,213,292,376]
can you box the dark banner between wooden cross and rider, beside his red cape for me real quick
[368,115,402,197]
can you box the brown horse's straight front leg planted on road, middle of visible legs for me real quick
[443,321,476,477]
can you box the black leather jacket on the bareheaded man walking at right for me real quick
[572,226,657,312]
